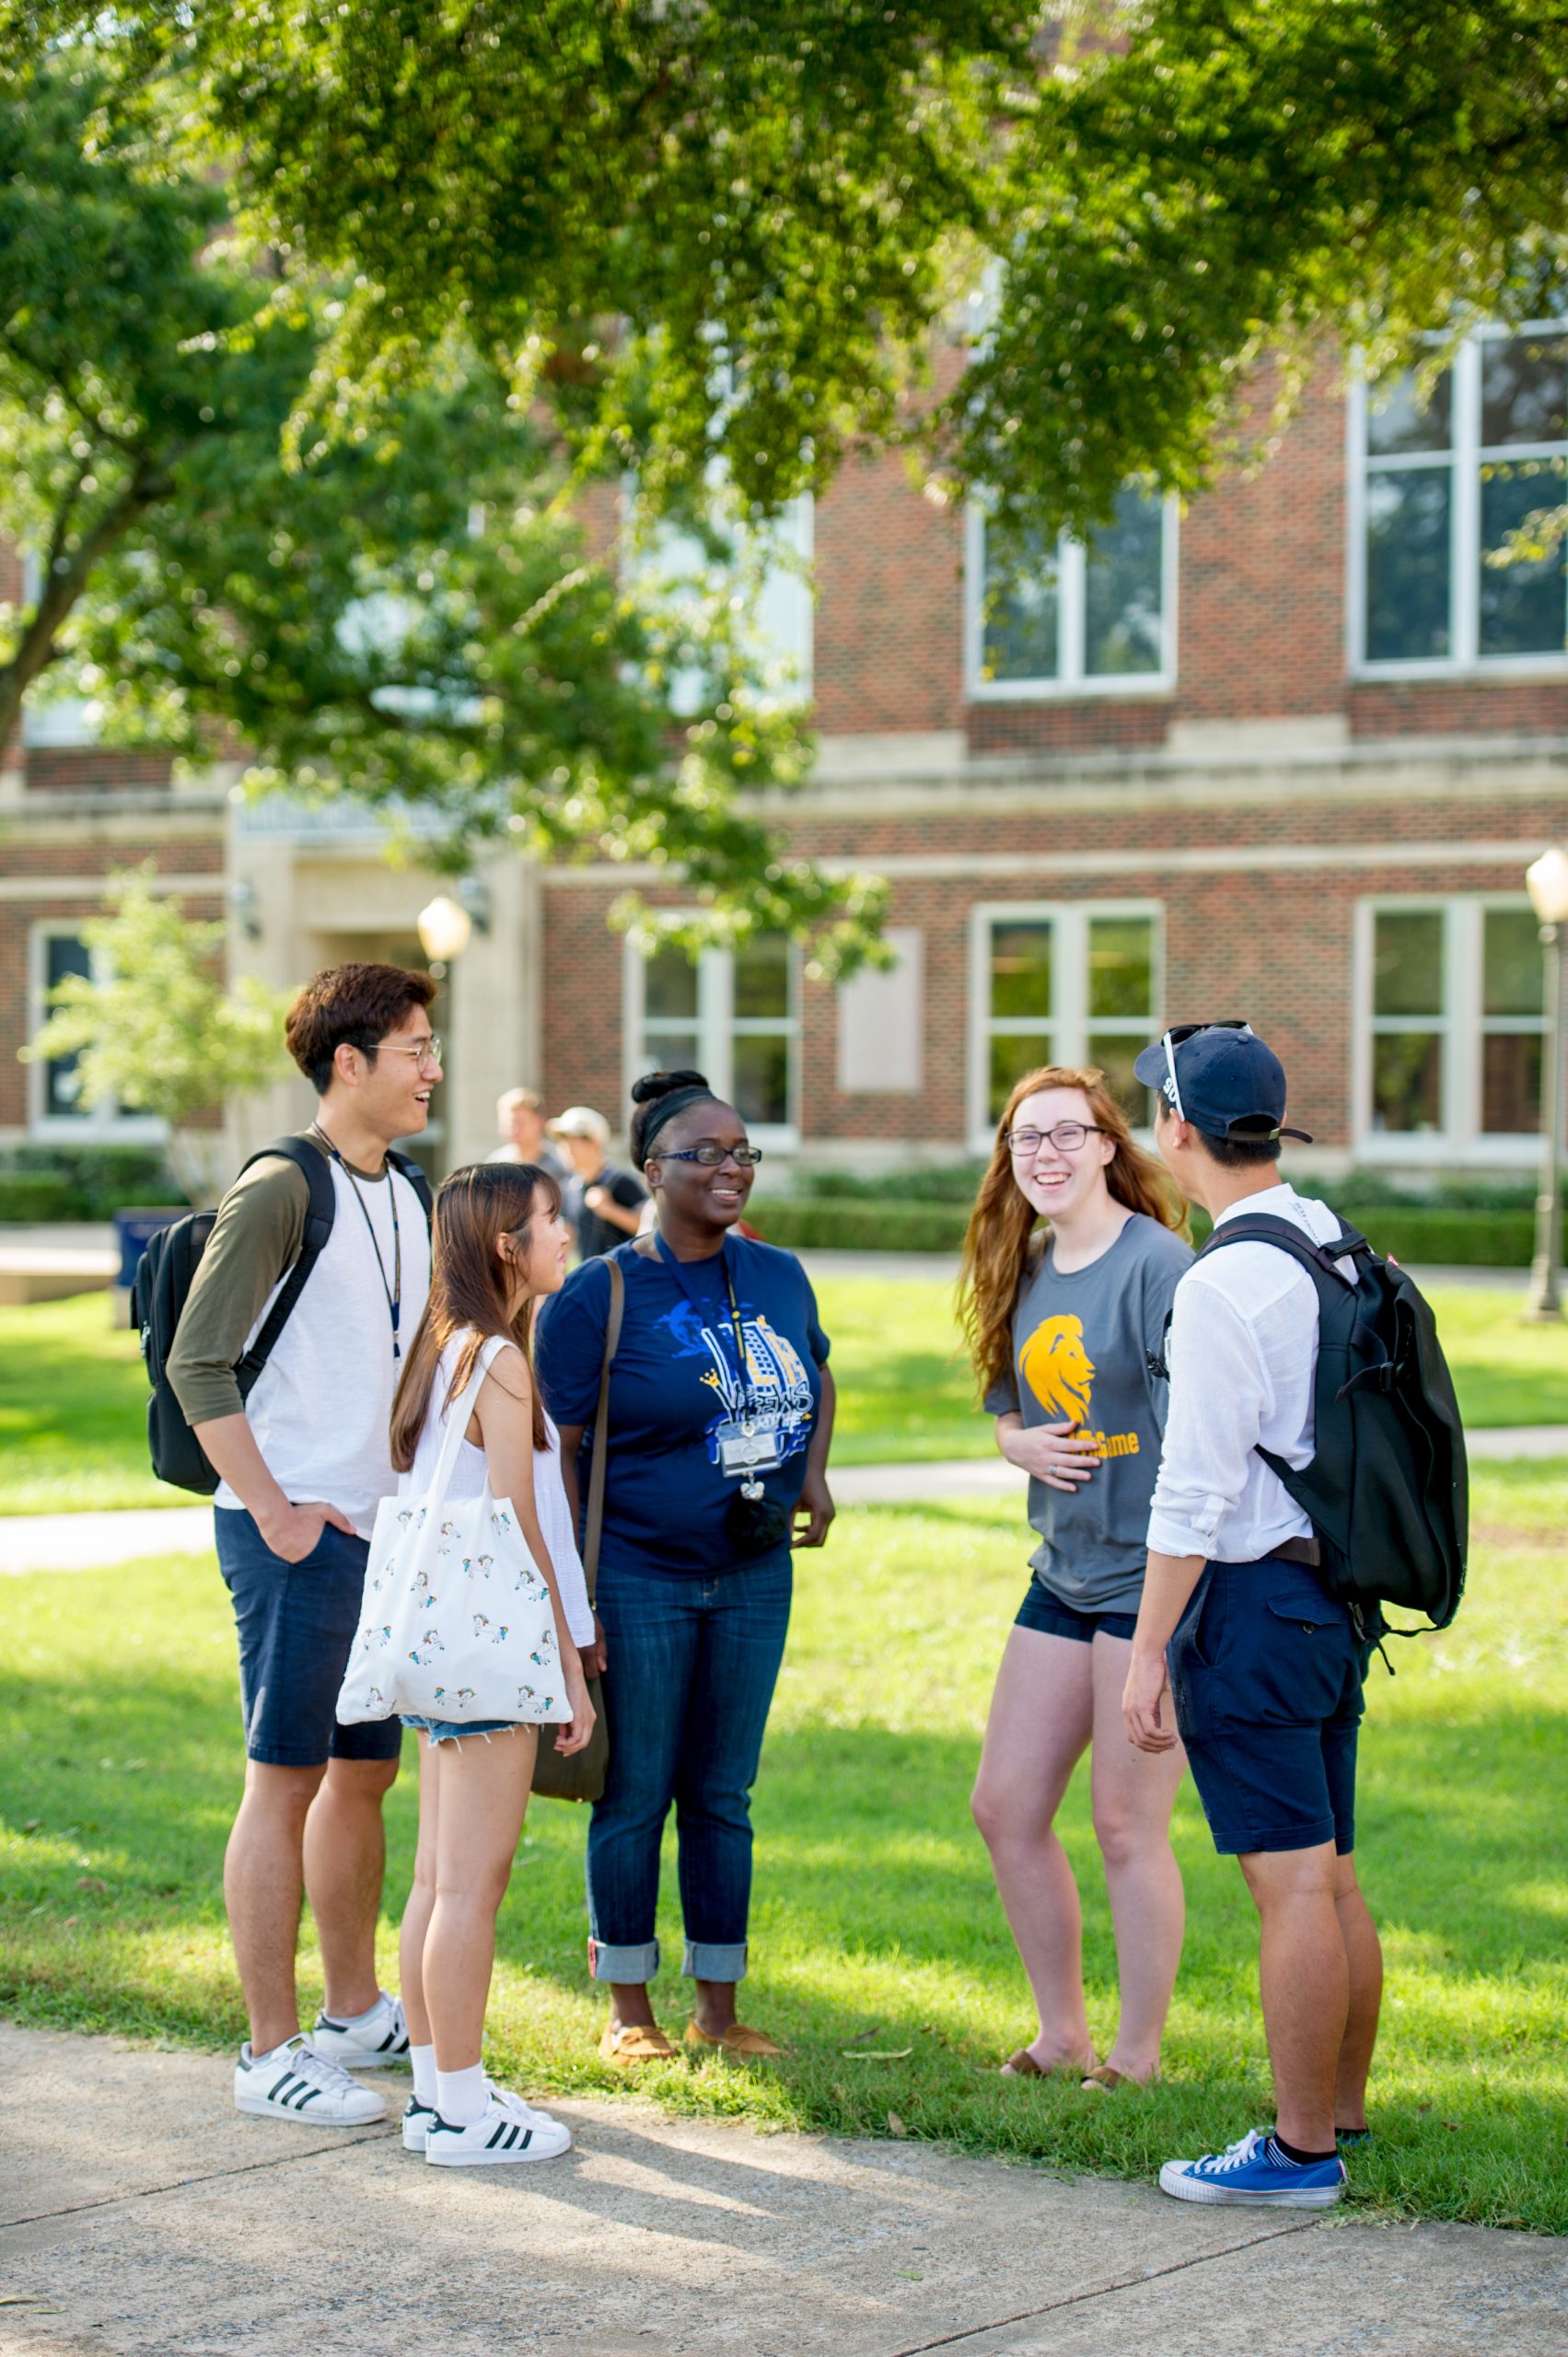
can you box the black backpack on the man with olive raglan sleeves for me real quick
[130,1136,432,1497]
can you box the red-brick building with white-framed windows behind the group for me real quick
[0,330,1568,1174]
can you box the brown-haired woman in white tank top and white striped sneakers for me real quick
[391,1162,594,2166]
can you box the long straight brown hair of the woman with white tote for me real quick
[391,1162,561,1473]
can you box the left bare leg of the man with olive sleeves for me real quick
[224,1760,325,2055]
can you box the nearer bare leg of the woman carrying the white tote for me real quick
[420,1725,538,2072]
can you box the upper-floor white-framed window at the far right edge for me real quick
[1349,320,1568,679]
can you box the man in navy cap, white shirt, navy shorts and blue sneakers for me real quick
[1122,1023,1382,2209]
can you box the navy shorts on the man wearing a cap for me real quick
[1167,1556,1372,1857]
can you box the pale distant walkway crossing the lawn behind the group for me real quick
[0,1423,1568,1574]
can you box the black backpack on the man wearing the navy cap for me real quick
[1198,1216,1469,1636]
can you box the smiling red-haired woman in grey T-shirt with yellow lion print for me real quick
[959,1065,1191,2088]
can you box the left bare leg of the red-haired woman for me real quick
[971,1626,1094,2070]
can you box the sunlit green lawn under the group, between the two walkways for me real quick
[0,1464,1568,2232]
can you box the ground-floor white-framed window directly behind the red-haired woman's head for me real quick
[970,900,1165,1150]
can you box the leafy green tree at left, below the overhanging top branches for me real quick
[0,66,875,969]
